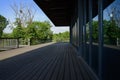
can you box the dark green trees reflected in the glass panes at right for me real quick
[92,20,120,45]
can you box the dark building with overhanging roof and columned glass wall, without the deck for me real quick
[34,0,117,80]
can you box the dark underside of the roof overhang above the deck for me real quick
[34,0,114,26]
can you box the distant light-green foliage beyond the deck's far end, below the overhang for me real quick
[53,31,69,42]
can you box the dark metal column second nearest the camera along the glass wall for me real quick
[89,0,92,66]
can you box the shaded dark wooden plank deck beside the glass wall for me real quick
[0,43,98,80]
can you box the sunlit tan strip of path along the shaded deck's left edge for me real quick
[0,42,53,60]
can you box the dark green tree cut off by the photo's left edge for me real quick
[0,15,8,38]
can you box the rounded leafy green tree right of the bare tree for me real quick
[26,21,53,44]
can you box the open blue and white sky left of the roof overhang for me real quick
[0,0,69,33]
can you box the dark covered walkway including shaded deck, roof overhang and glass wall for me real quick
[0,0,120,80]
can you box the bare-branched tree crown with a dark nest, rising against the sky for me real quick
[11,3,36,27]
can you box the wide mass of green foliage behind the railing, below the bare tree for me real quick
[13,21,53,44]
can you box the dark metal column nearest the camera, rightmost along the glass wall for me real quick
[98,0,104,80]
